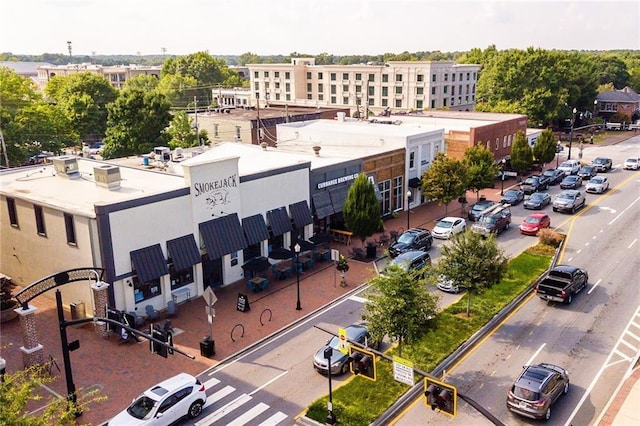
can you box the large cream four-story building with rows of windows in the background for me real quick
[247,58,480,116]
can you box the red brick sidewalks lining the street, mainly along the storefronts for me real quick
[0,132,640,425]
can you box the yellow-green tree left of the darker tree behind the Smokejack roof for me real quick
[45,72,118,139]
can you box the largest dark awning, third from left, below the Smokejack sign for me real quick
[199,213,247,259]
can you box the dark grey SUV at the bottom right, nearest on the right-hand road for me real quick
[507,363,569,420]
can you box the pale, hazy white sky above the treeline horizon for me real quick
[0,0,640,56]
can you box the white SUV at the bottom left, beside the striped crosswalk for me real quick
[107,373,207,426]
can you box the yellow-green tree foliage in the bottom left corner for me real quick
[0,365,106,426]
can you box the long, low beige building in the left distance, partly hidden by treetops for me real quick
[38,63,162,89]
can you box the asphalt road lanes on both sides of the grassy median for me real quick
[178,137,640,425]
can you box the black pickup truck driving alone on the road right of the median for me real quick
[536,265,589,305]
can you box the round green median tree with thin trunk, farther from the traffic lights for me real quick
[437,230,507,317]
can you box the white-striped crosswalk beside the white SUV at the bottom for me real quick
[189,377,288,426]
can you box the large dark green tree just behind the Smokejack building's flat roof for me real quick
[102,89,171,158]
